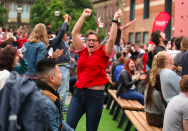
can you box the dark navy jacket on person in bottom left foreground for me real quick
[0,71,52,131]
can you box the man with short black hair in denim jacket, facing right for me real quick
[36,58,74,131]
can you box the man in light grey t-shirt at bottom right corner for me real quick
[163,75,188,131]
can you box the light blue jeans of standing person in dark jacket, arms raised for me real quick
[57,66,70,111]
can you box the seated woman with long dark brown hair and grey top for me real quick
[144,73,165,127]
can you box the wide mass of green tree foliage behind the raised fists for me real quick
[30,0,104,39]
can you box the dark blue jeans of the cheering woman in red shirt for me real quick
[66,88,105,131]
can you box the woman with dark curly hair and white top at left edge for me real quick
[0,46,19,90]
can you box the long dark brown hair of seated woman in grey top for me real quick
[146,74,164,107]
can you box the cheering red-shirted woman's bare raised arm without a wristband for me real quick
[72,8,92,51]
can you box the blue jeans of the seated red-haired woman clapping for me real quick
[120,89,144,105]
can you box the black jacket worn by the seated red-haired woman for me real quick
[116,69,139,97]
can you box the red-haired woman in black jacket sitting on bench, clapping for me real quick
[116,59,146,105]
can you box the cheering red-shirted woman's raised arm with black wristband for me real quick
[105,9,122,56]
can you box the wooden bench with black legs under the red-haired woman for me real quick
[106,89,145,128]
